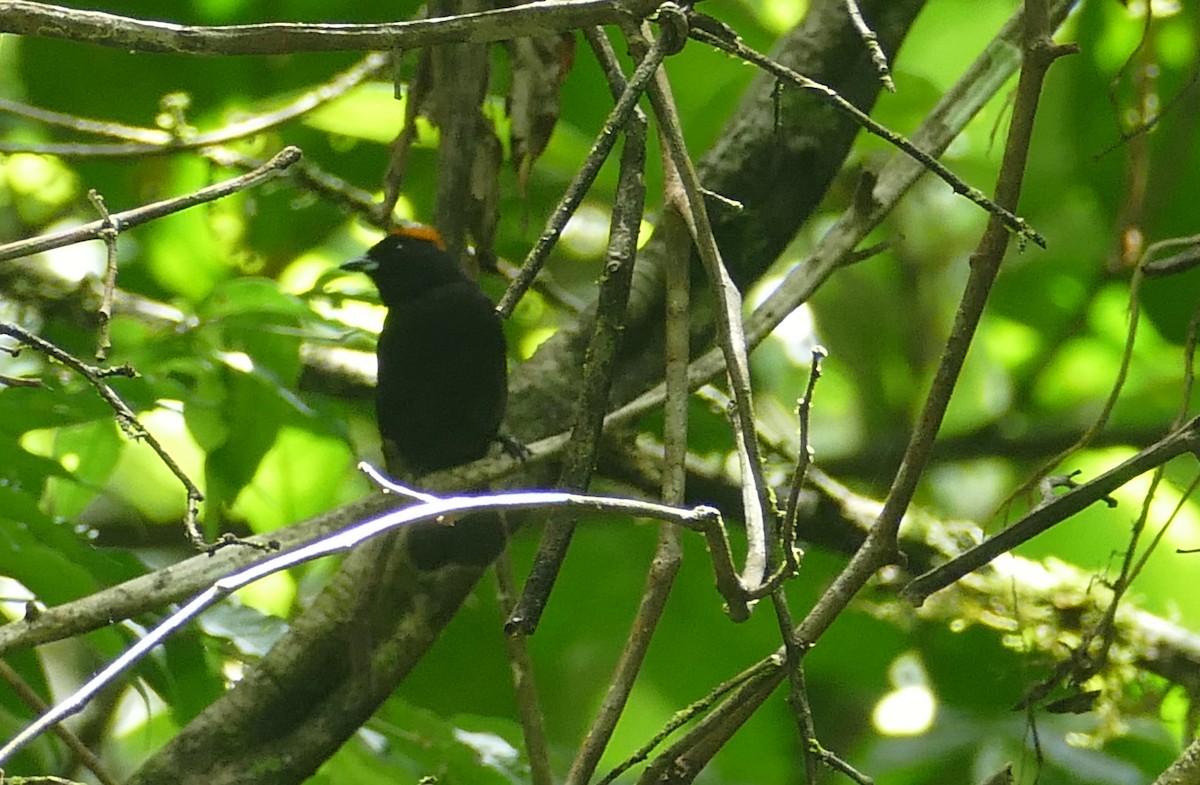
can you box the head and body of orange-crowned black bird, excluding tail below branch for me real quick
[342,226,508,477]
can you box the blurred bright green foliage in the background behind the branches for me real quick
[0,0,1200,785]
